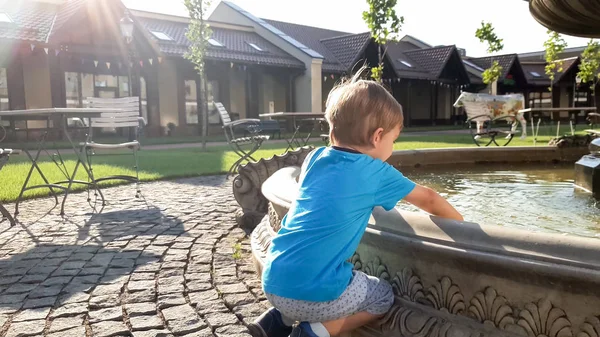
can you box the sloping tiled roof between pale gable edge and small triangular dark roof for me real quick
[264,19,350,71]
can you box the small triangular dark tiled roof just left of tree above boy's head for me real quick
[321,33,371,71]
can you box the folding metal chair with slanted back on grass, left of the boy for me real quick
[215,102,270,176]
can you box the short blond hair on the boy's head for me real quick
[325,71,404,146]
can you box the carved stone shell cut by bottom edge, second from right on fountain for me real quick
[517,299,573,337]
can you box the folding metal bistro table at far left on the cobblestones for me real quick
[0,108,122,218]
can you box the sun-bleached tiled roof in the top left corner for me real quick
[0,1,59,42]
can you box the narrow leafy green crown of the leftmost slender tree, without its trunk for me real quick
[184,0,212,73]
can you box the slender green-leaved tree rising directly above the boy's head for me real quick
[363,0,404,82]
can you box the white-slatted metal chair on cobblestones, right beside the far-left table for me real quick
[77,97,146,206]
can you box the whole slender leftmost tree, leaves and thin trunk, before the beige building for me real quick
[184,0,212,150]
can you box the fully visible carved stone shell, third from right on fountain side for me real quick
[469,287,515,330]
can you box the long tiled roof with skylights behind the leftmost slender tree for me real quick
[137,17,304,68]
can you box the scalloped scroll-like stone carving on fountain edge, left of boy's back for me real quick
[233,147,313,229]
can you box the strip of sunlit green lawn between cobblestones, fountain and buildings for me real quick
[0,128,592,202]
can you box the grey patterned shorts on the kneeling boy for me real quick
[266,271,394,323]
